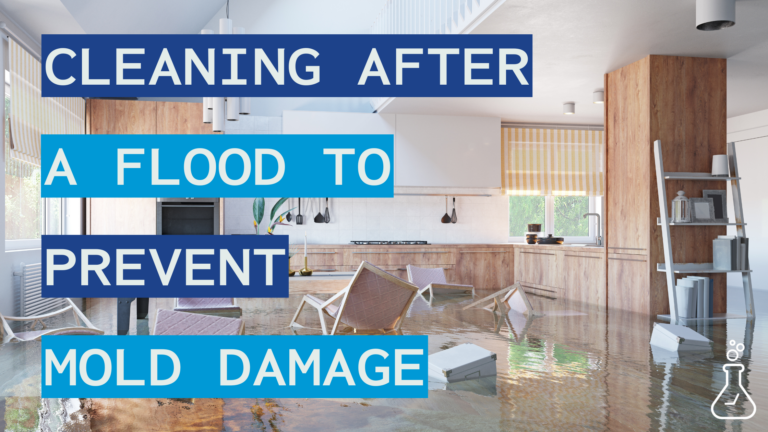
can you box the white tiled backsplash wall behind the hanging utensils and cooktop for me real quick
[224,116,508,244]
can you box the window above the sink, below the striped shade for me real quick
[509,195,602,243]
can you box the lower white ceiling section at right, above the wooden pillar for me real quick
[382,0,768,124]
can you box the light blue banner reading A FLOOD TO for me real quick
[41,135,395,198]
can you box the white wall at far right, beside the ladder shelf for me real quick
[728,110,768,290]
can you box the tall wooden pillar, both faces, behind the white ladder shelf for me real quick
[605,56,727,315]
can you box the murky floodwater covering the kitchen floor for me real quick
[0,289,768,431]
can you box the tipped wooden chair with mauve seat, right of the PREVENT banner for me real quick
[290,261,419,335]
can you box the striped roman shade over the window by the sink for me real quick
[501,128,605,196]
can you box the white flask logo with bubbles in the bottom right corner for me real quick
[711,340,757,420]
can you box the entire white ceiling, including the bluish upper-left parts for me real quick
[0,0,768,124]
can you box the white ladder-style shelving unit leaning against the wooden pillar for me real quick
[653,140,755,324]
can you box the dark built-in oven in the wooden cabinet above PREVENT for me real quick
[157,198,220,235]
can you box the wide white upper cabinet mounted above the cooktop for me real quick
[283,111,501,188]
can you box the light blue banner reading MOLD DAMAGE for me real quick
[41,336,428,398]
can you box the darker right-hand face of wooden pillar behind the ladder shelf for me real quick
[649,56,727,313]
